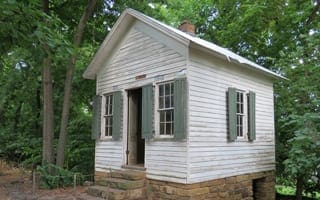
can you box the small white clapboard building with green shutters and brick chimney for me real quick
[83,9,282,199]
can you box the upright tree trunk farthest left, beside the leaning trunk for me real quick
[42,0,54,164]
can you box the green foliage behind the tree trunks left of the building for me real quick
[0,0,96,174]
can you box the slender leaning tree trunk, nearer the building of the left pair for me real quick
[56,0,97,167]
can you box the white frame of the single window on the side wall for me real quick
[236,89,249,141]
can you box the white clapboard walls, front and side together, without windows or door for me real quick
[95,18,275,183]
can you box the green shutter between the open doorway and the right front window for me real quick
[141,84,153,139]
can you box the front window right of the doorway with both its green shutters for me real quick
[142,77,188,140]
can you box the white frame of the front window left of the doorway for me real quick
[101,93,114,139]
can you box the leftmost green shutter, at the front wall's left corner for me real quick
[91,95,102,140]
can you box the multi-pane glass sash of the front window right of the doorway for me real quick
[158,82,174,136]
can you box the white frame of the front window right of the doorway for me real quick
[154,80,174,138]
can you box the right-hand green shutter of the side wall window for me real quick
[248,91,256,141]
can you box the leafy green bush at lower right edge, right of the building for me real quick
[284,113,320,196]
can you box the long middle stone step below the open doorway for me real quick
[96,178,145,190]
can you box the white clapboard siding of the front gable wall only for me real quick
[95,26,187,183]
